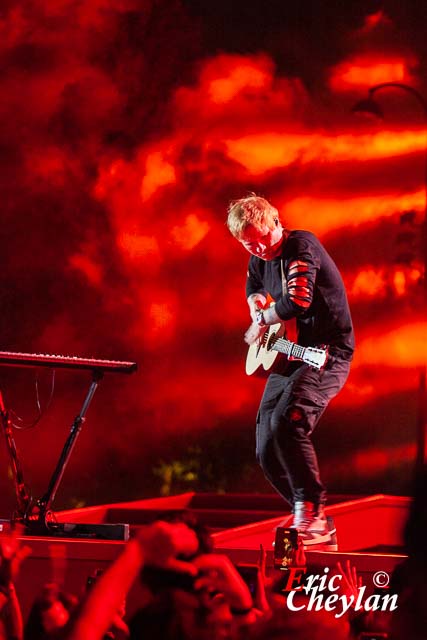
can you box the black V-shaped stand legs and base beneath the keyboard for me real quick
[0,369,129,540]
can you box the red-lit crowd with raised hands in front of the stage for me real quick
[0,468,427,640]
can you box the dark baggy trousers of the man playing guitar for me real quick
[256,357,350,506]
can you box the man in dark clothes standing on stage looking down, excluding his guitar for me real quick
[227,194,354,548]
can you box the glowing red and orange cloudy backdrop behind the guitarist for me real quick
[0,0,427,515]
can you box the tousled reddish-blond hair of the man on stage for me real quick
[227,193,279,239]
